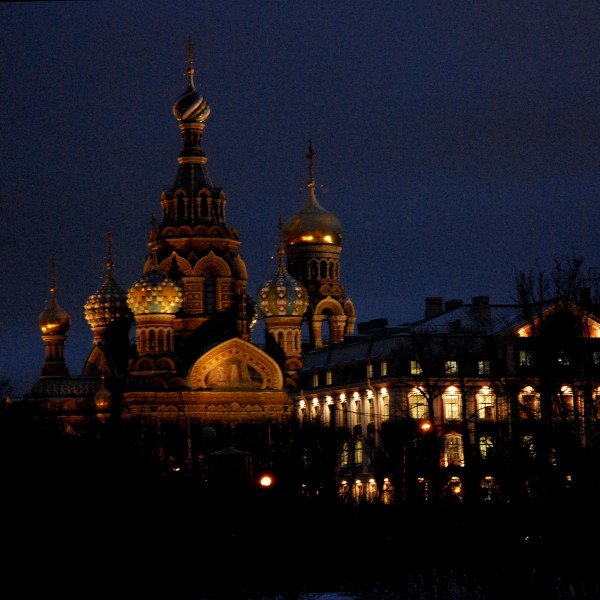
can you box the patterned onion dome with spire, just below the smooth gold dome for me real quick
[256,248,308,317]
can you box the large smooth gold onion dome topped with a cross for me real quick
[283,143,342,246]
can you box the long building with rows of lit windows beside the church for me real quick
[295,293,600,502]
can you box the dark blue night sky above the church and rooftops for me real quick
[0,0,600,394]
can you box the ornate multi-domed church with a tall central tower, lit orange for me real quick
[18,45,355,490]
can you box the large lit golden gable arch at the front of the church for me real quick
[187,338,283,390]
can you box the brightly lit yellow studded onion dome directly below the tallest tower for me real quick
[127,266,183,315]
